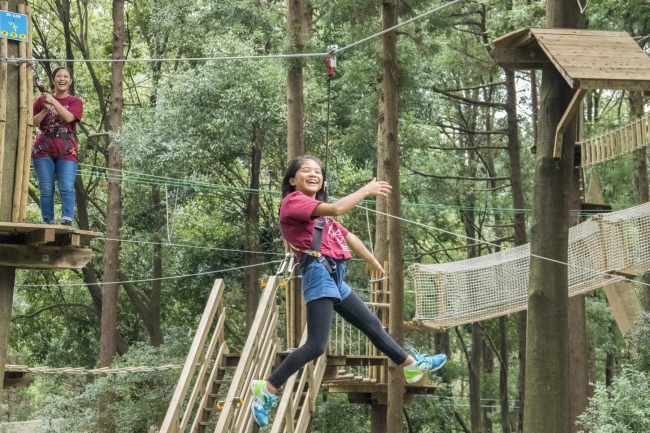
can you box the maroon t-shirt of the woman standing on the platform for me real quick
[33,95,84,162]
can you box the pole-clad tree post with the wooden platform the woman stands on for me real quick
[0,0,102,388]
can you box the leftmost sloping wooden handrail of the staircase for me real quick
[160,280,228,433]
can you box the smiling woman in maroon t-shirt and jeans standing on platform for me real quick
[32,66,83,226]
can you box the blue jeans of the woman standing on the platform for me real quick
[32,156,78,224]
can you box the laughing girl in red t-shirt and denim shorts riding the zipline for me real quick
[251,156,447,427]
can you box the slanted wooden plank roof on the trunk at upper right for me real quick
[492,27,650,91]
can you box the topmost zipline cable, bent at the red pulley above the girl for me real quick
[0,0,466,64]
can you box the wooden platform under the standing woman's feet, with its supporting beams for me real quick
[0,222,102,270]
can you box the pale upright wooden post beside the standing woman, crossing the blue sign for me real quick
[11,4,27,222]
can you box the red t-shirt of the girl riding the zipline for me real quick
[280,191,352,260]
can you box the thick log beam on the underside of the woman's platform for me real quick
[0,245,93,270]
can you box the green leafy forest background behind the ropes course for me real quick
[0,0,650,433]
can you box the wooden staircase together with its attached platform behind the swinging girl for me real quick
[160,260,436,433]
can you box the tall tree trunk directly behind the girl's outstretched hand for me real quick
[381,0,404,432]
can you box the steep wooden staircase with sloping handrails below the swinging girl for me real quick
[160,276,327,433]
